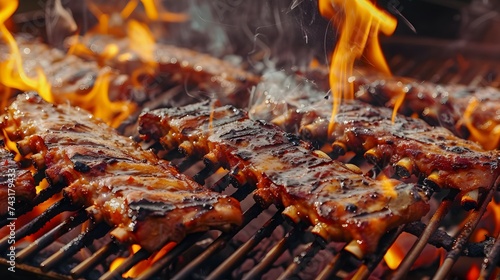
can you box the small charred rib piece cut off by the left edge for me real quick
[0,142,36,218]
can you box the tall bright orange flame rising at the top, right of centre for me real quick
[318,0,397,134]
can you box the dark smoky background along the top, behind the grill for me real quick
[16,0,500,70]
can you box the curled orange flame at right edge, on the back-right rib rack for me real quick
[459,97,500,150]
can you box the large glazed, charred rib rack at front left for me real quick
[3,93,242,251]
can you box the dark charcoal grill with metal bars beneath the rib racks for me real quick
[0,1,500,279]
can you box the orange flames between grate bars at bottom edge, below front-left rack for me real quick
[109,242,177,278]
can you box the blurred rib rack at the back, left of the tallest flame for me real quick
[67,34,259,106]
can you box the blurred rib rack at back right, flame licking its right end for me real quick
[304,69,500,150]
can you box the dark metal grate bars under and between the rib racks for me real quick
[0,38,500,279]
